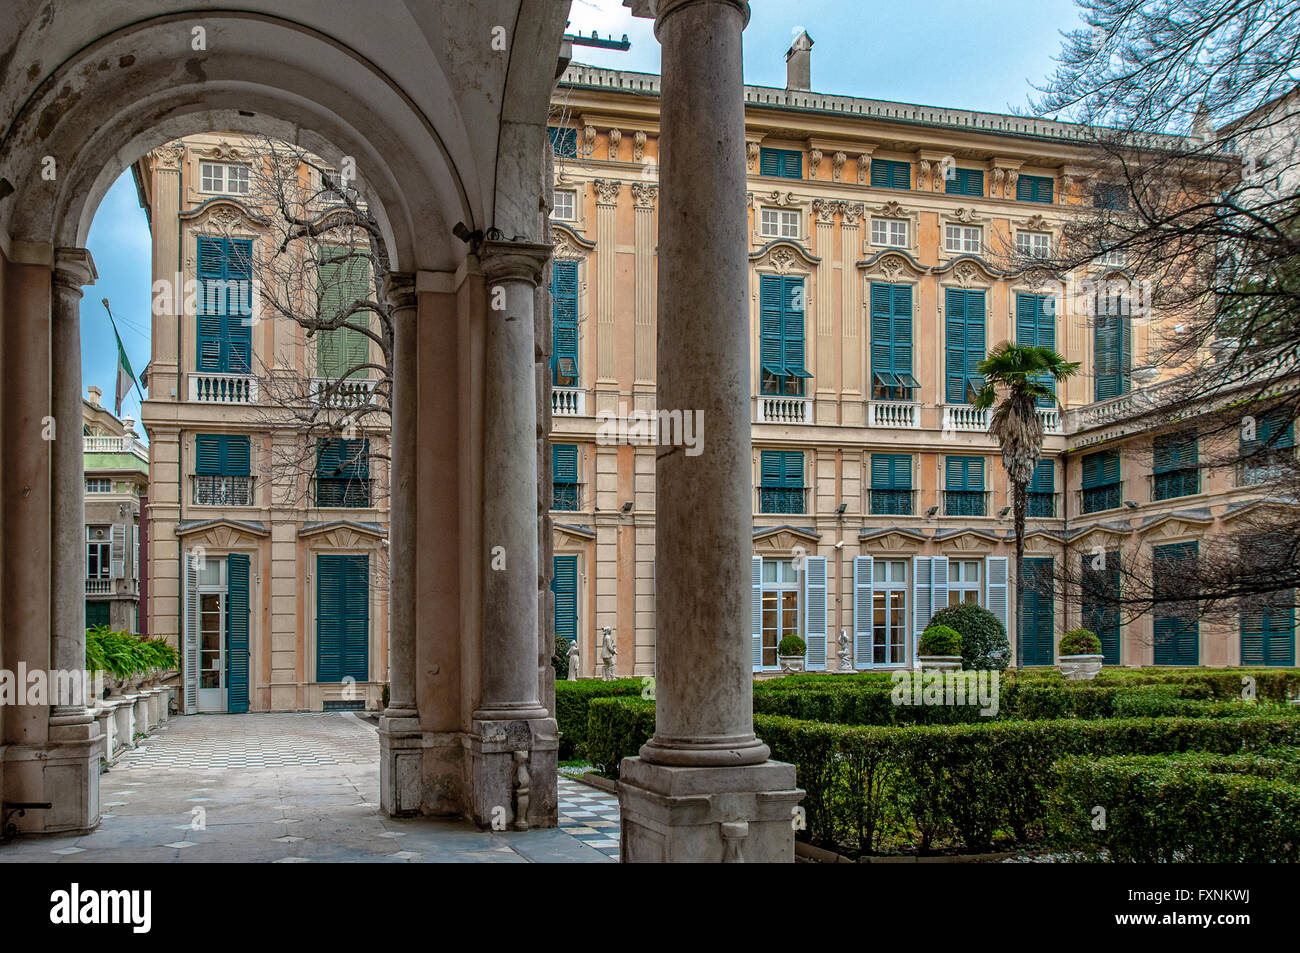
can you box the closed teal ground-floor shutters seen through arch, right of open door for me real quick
[316,553,371,681]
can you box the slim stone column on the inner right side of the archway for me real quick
[380,273,423,816]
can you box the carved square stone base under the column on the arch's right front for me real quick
[468,712,559,831]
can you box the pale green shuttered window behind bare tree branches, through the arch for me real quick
[316,246,373,381]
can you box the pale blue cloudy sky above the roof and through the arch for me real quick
[81,0,1082,426]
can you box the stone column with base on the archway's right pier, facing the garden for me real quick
[471,242,558,827]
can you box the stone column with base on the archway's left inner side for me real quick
[47,248,101,831]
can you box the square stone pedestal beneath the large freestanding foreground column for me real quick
[619,758,803,863]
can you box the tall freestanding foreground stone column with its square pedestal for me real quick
[619,0,800,862]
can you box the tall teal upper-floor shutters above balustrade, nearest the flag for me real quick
[196,235,252,374]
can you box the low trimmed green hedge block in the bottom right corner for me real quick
[1047,754,1300,863]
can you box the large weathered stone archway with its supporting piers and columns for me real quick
[0,0,568,831]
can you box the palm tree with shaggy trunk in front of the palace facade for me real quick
[975,341,1079,665]
